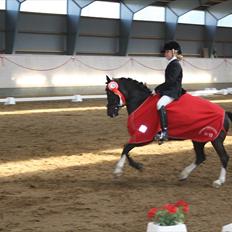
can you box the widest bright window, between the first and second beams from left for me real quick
[20,0,67,14]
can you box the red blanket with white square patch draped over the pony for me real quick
[128,93,225,143]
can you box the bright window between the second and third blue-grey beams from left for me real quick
[81,1,120,19]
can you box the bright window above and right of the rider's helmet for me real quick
[178,10,205,25]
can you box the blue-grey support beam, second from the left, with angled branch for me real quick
[67,0,94,55]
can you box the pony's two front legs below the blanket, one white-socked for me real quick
[113,143,143,176]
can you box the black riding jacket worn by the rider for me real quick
[155,59,186,99]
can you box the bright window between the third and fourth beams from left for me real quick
[134,6,165,22]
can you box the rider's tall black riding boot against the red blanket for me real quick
[155,106,168,144]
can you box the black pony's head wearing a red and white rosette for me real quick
[106,76,126,117]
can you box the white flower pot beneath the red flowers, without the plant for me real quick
[147,222,187,232]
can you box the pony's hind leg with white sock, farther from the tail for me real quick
[179,141,206,180]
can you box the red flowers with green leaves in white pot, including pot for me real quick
[147,200,189,232]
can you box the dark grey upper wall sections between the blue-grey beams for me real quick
[0,11,232,57]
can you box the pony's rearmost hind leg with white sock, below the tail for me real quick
[212,131,229,188]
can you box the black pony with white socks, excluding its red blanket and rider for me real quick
[106,76,232,188]
